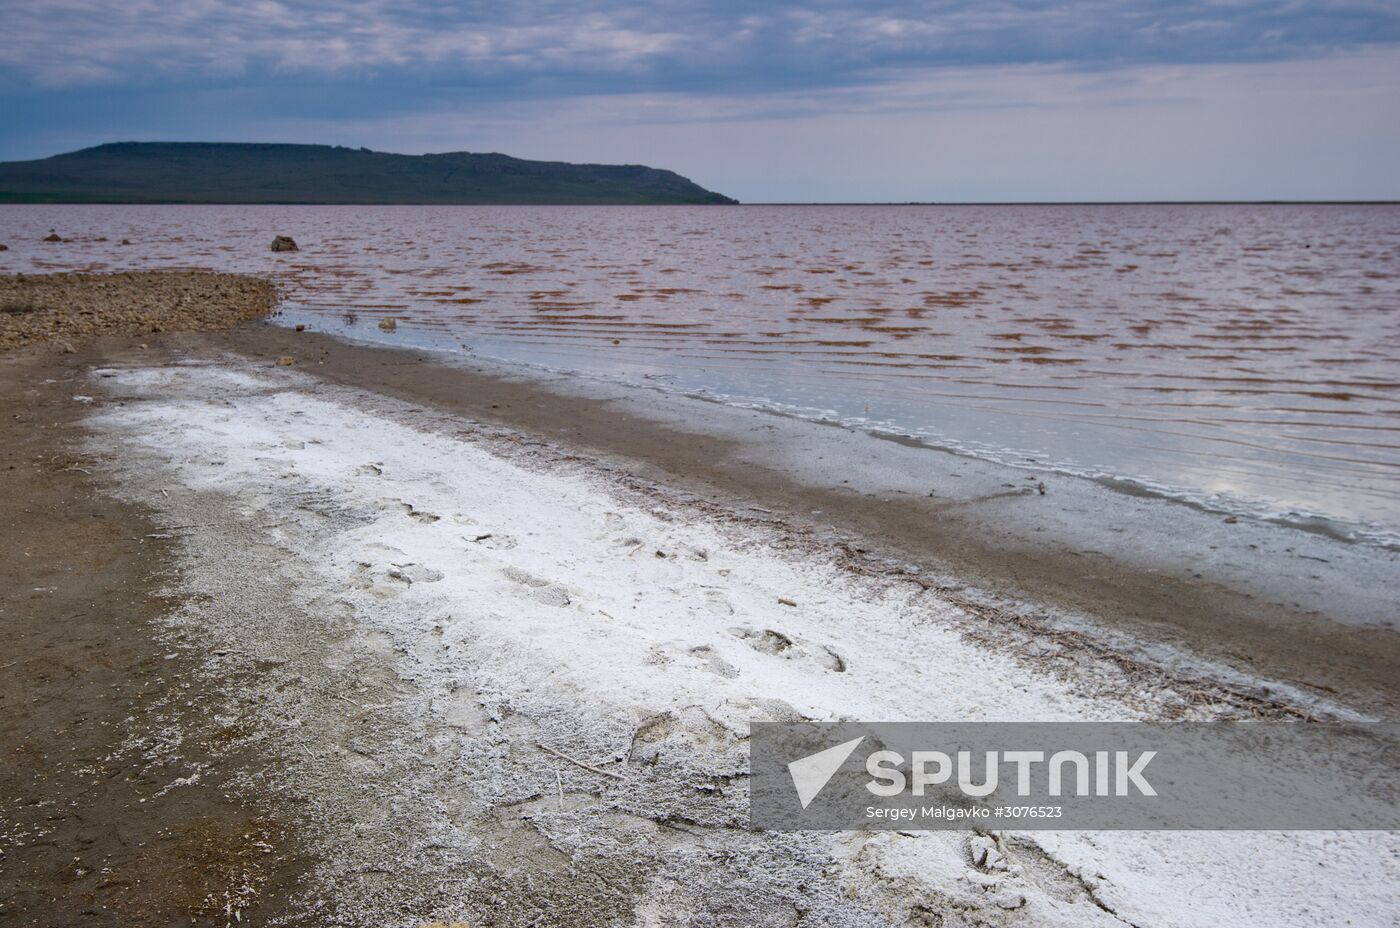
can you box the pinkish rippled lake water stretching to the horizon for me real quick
[0,206,1400,544]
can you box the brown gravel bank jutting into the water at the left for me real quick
[0,270,277,350]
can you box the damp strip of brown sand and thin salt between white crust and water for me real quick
[220,323,1400,715]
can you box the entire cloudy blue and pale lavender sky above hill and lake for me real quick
[0,0,1400,202]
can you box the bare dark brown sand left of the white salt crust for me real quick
[0,340,305,928]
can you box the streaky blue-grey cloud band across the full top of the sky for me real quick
[0,0,1400,92]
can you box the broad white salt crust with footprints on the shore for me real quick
[81,361,1400,927]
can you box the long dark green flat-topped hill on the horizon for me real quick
[0,141,735,203]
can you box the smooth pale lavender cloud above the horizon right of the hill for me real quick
[226,49,1400,202]
